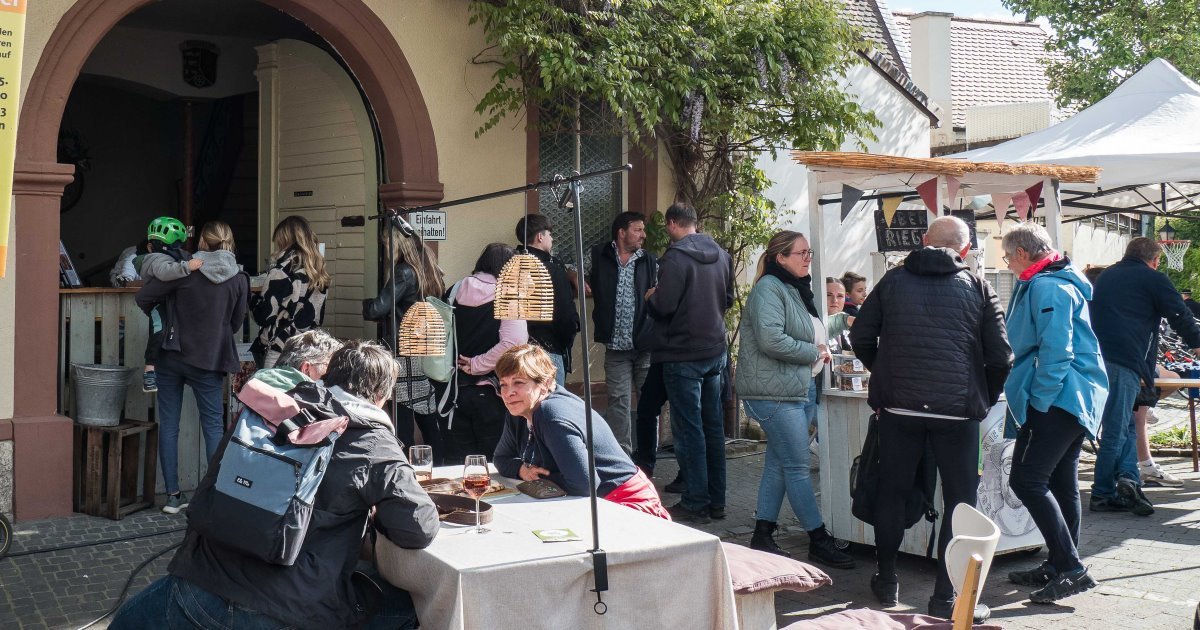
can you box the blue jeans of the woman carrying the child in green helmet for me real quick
[155,352,226,494]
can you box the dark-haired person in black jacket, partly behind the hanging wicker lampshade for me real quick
[516,215,580,385]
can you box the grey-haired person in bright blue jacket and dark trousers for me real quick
[1003,221,1109,604]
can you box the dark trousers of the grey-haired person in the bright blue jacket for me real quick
[1008,407,1086,574]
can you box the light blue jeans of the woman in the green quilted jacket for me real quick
[742,398,823,530]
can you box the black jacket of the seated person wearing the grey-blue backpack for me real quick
[167,388,440,630]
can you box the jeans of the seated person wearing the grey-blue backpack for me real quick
[108,574,416,630]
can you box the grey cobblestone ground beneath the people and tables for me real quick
[0,403,1200,630]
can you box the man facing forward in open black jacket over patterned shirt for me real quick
[588,212,659,455]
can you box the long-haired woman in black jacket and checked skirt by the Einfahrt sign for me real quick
[362,229,446,462]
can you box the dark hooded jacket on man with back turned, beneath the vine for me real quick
[646,233,733,362]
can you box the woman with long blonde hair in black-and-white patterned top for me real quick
[251,215,330,367]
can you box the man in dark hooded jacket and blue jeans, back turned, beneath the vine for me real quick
[647,203,733,523]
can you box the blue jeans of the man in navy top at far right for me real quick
[1092,361,1141,499]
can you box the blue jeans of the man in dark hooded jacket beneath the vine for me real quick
[662,353,725,511]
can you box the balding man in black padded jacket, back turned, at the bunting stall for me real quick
[850,217,1013,623]
